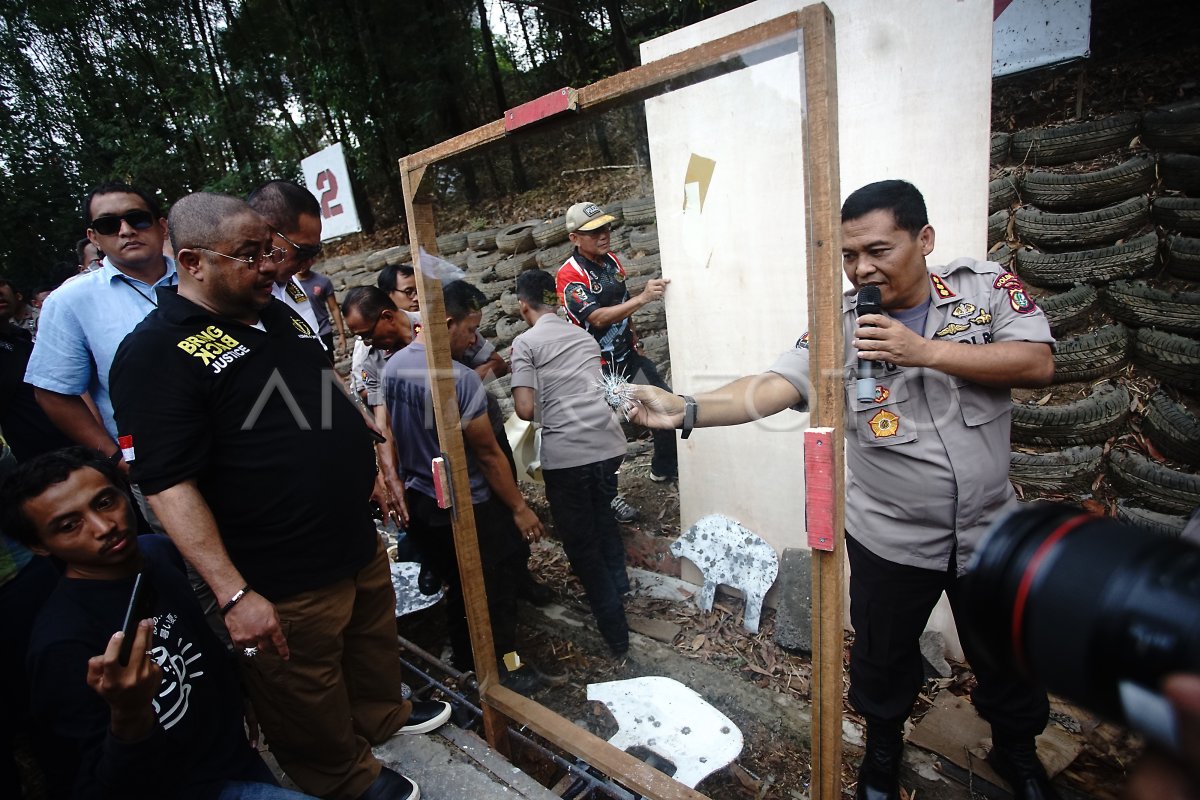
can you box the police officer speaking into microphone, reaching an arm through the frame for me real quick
[629,180,1057,800]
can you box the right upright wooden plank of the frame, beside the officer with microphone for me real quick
[798,4,845,800]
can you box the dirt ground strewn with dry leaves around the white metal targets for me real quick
[401,444,1141,800]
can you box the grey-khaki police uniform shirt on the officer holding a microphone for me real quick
[770,258,1054,573]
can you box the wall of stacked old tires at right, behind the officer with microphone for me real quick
[988,102,1200,533]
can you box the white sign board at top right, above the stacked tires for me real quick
[991,0,1092,77]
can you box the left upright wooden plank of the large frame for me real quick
[400,158,509,756]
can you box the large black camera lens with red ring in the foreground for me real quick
[960,503,1200,738]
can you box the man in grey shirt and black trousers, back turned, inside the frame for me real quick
[512,270,629,657]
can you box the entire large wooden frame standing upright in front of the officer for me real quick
[400,4,844,800]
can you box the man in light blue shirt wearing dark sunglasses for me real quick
[25,182,178,470]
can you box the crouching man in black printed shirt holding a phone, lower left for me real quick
[0,446,305,800]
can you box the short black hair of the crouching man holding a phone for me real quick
[0,445,130,547]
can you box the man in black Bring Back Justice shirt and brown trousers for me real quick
[112,193,450,800]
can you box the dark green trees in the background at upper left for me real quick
[0,0,739,285]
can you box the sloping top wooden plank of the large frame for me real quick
[401,12,806,169]
